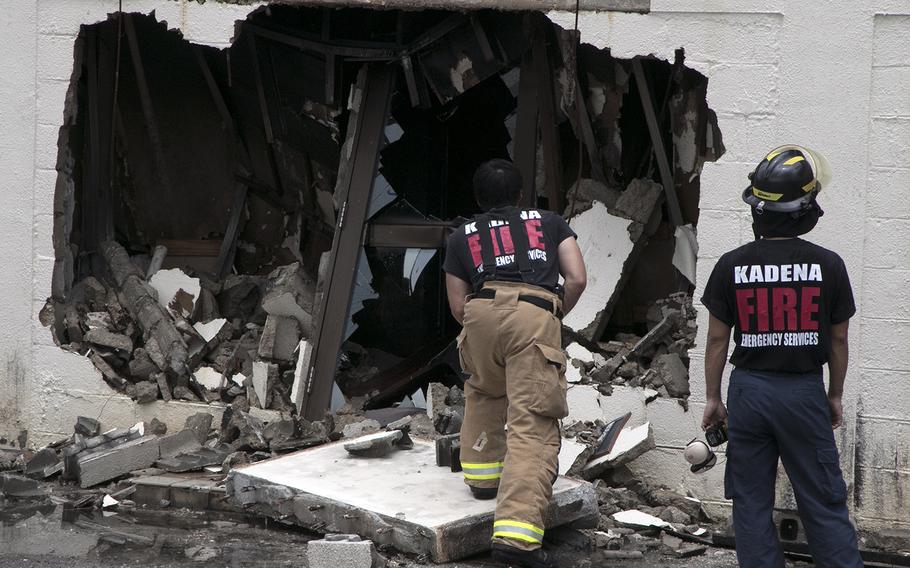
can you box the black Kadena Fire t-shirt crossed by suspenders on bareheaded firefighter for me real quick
[442,209,577,291]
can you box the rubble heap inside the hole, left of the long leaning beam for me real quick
[54,246,324,411]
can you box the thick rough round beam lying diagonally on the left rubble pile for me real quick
[101,241,189,381]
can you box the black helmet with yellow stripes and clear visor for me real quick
[743,144,831,217]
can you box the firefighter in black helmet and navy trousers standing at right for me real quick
[702,146,863,568]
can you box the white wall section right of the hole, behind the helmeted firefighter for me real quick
[550,0,910,530]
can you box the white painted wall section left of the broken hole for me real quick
[0,0,256,445]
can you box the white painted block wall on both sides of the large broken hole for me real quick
[0,0,910,528]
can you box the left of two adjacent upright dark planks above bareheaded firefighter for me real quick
[513,50,537,207]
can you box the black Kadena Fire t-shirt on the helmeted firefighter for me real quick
[701,239,856,373]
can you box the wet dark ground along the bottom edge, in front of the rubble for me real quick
[0,494,820,568]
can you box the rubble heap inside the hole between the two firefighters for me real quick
[566,292,697,402]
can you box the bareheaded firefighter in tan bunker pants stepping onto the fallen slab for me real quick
[443,160,586,567]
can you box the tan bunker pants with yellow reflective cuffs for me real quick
[458,282,568,550]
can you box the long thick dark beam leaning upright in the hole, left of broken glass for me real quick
[302,65,395,420]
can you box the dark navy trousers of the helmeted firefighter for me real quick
[724,369,863,568]
